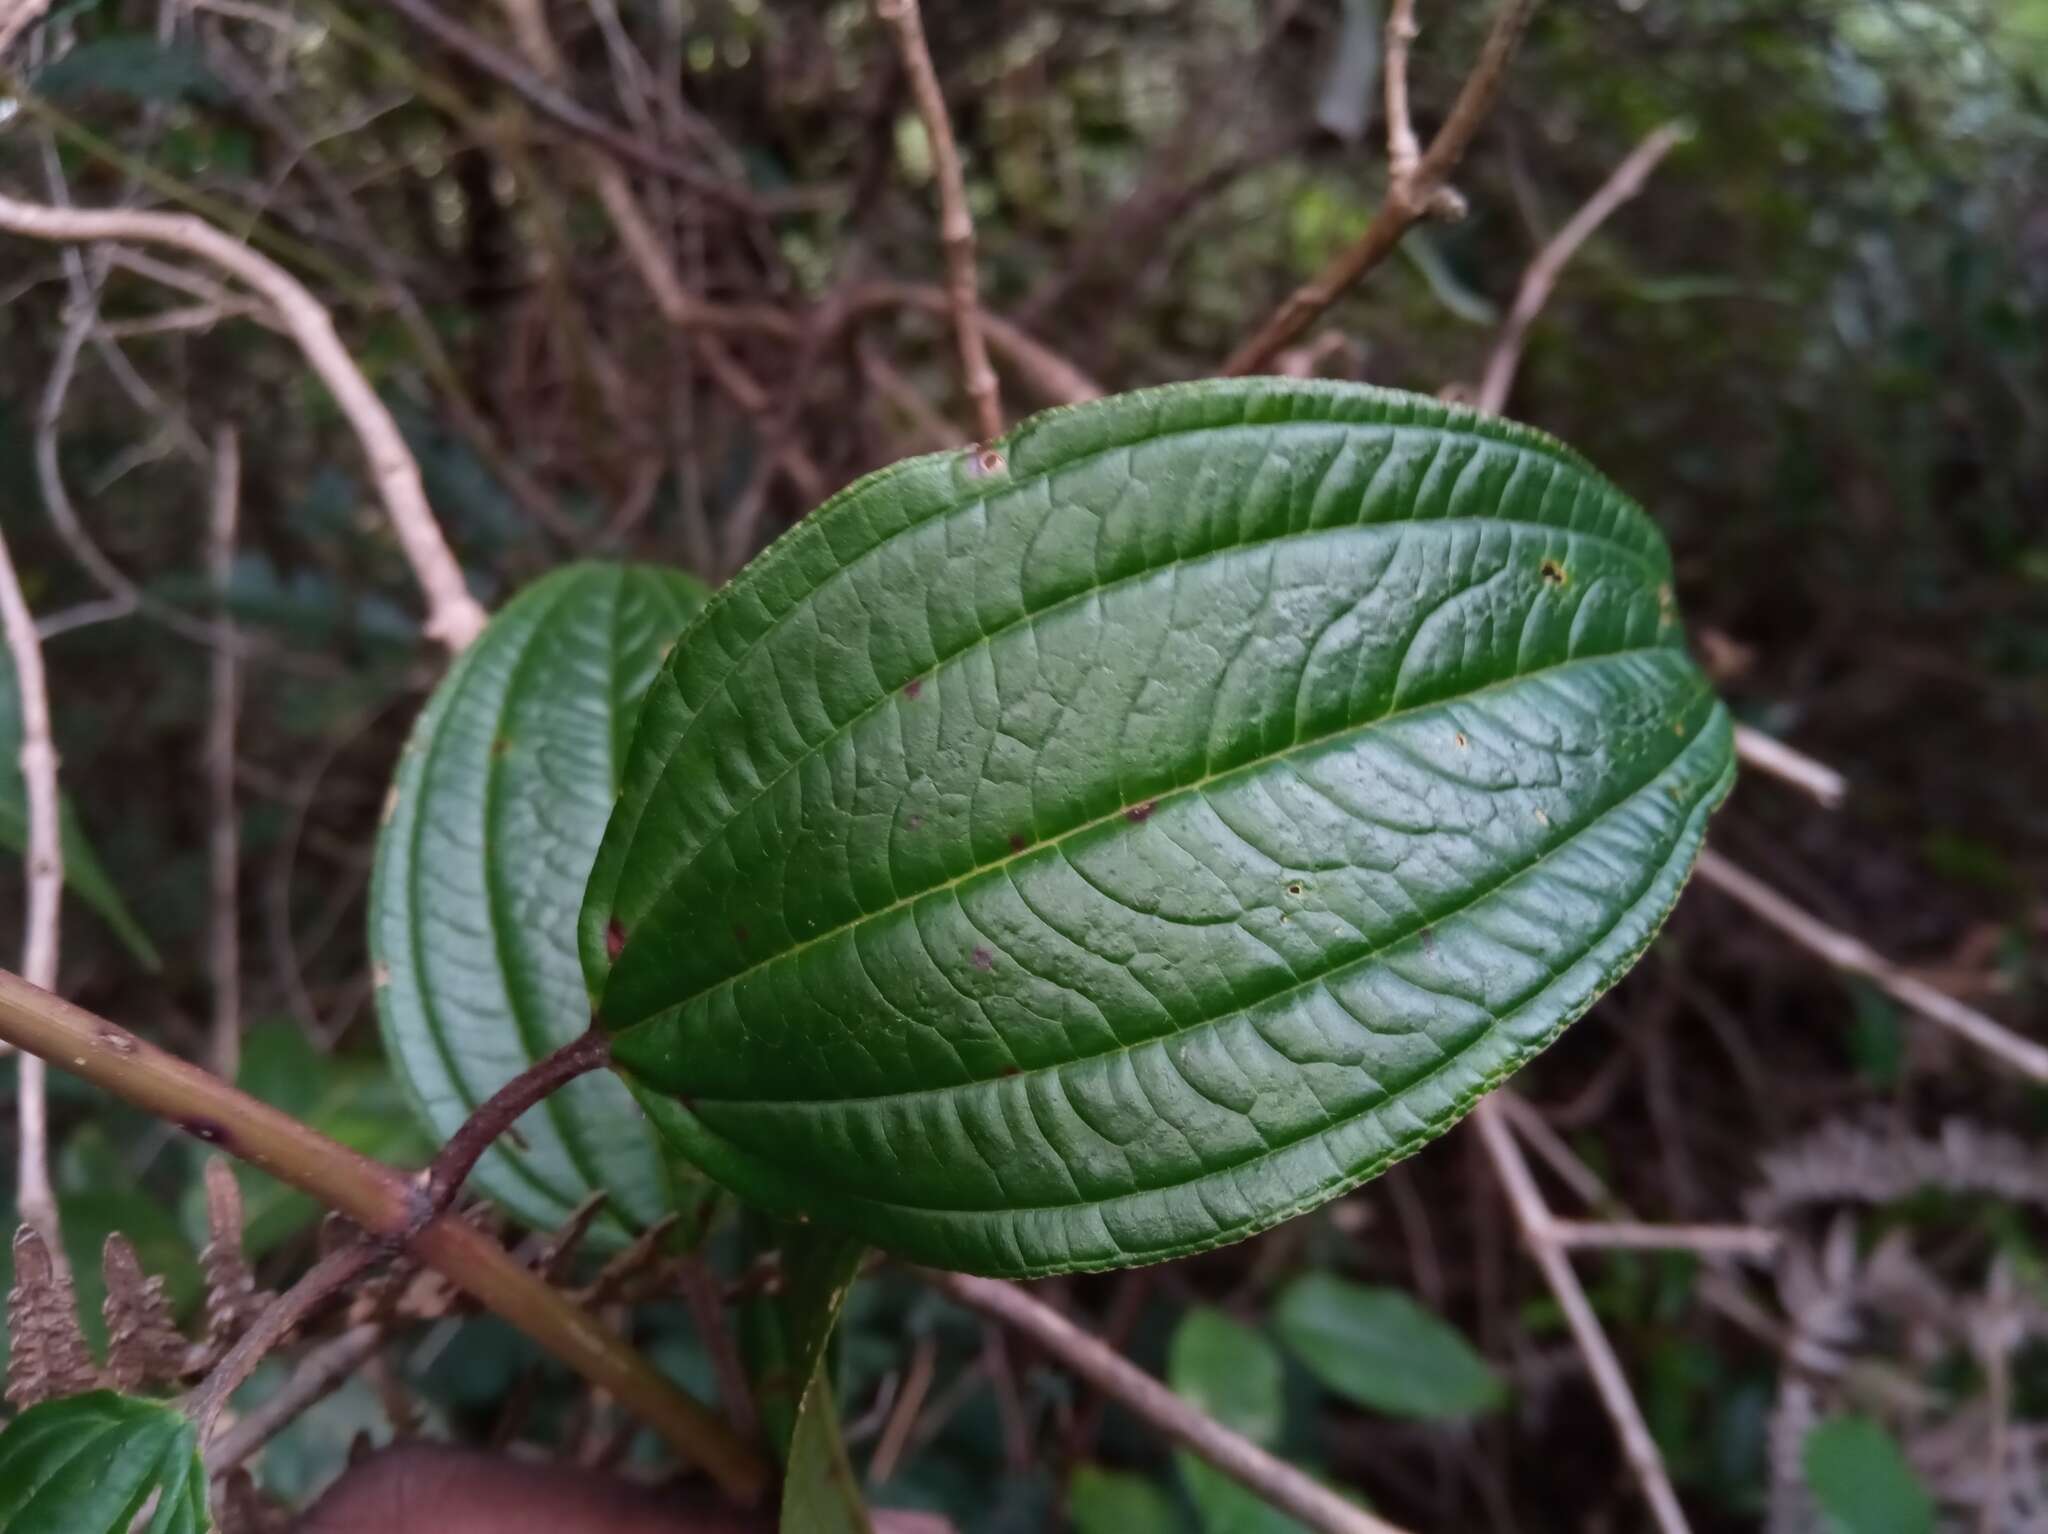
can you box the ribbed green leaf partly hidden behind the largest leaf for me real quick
[371,565,702,1243]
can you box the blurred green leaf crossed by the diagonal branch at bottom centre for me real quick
[1165,1307,1303,1534]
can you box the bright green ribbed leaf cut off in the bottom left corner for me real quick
[0,1391,213,1534]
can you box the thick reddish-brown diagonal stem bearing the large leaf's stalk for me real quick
[0,971,768,1505]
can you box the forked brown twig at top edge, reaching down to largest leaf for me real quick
[1221,0,1536,377]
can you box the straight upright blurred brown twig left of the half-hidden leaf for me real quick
[207,426,242,1081]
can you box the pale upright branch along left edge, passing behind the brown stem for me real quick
[0,507,63,1272]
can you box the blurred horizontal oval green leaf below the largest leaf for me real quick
[1274,1274,1507,1419]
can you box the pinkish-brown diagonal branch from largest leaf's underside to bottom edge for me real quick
[920,1270,1401,1534]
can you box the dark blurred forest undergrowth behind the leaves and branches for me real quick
[0,0,2048,1534]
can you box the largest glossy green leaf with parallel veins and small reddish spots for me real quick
[582,379,1733,1274]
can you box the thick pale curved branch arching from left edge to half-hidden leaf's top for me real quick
[0,197,483,649]
